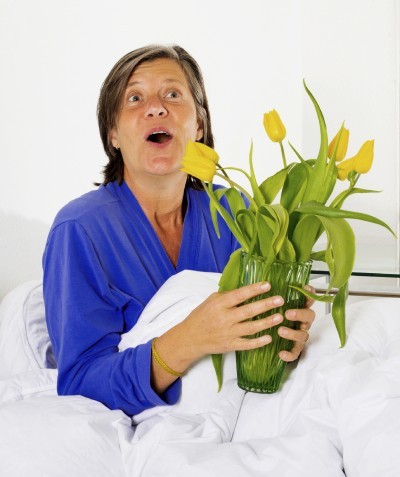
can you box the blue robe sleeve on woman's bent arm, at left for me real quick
[43,220,181,415]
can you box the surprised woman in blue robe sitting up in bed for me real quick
[43,46,314,415]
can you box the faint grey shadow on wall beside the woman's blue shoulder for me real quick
[0,211,50,300]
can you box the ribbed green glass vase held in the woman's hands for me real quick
[236,252,312,394]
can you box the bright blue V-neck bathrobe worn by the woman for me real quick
[43,182,238,415]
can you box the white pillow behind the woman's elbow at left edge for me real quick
[0,280,56,379]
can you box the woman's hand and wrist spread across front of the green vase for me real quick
[151,282,283,393]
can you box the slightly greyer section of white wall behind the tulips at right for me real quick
[301,0,400,273]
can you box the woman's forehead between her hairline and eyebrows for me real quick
[128,58,188,86]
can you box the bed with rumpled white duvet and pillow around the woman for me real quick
[0,271,400,477]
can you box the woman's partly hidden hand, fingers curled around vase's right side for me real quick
[278,286,315,362]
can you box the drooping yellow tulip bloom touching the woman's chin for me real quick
[181,141,219,182]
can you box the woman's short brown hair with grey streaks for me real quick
[97,45,214,188]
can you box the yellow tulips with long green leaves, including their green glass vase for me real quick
[182,83,394,393]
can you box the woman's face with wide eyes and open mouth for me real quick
[111,58,203,182]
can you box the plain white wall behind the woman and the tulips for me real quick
[0,0,399,298]
